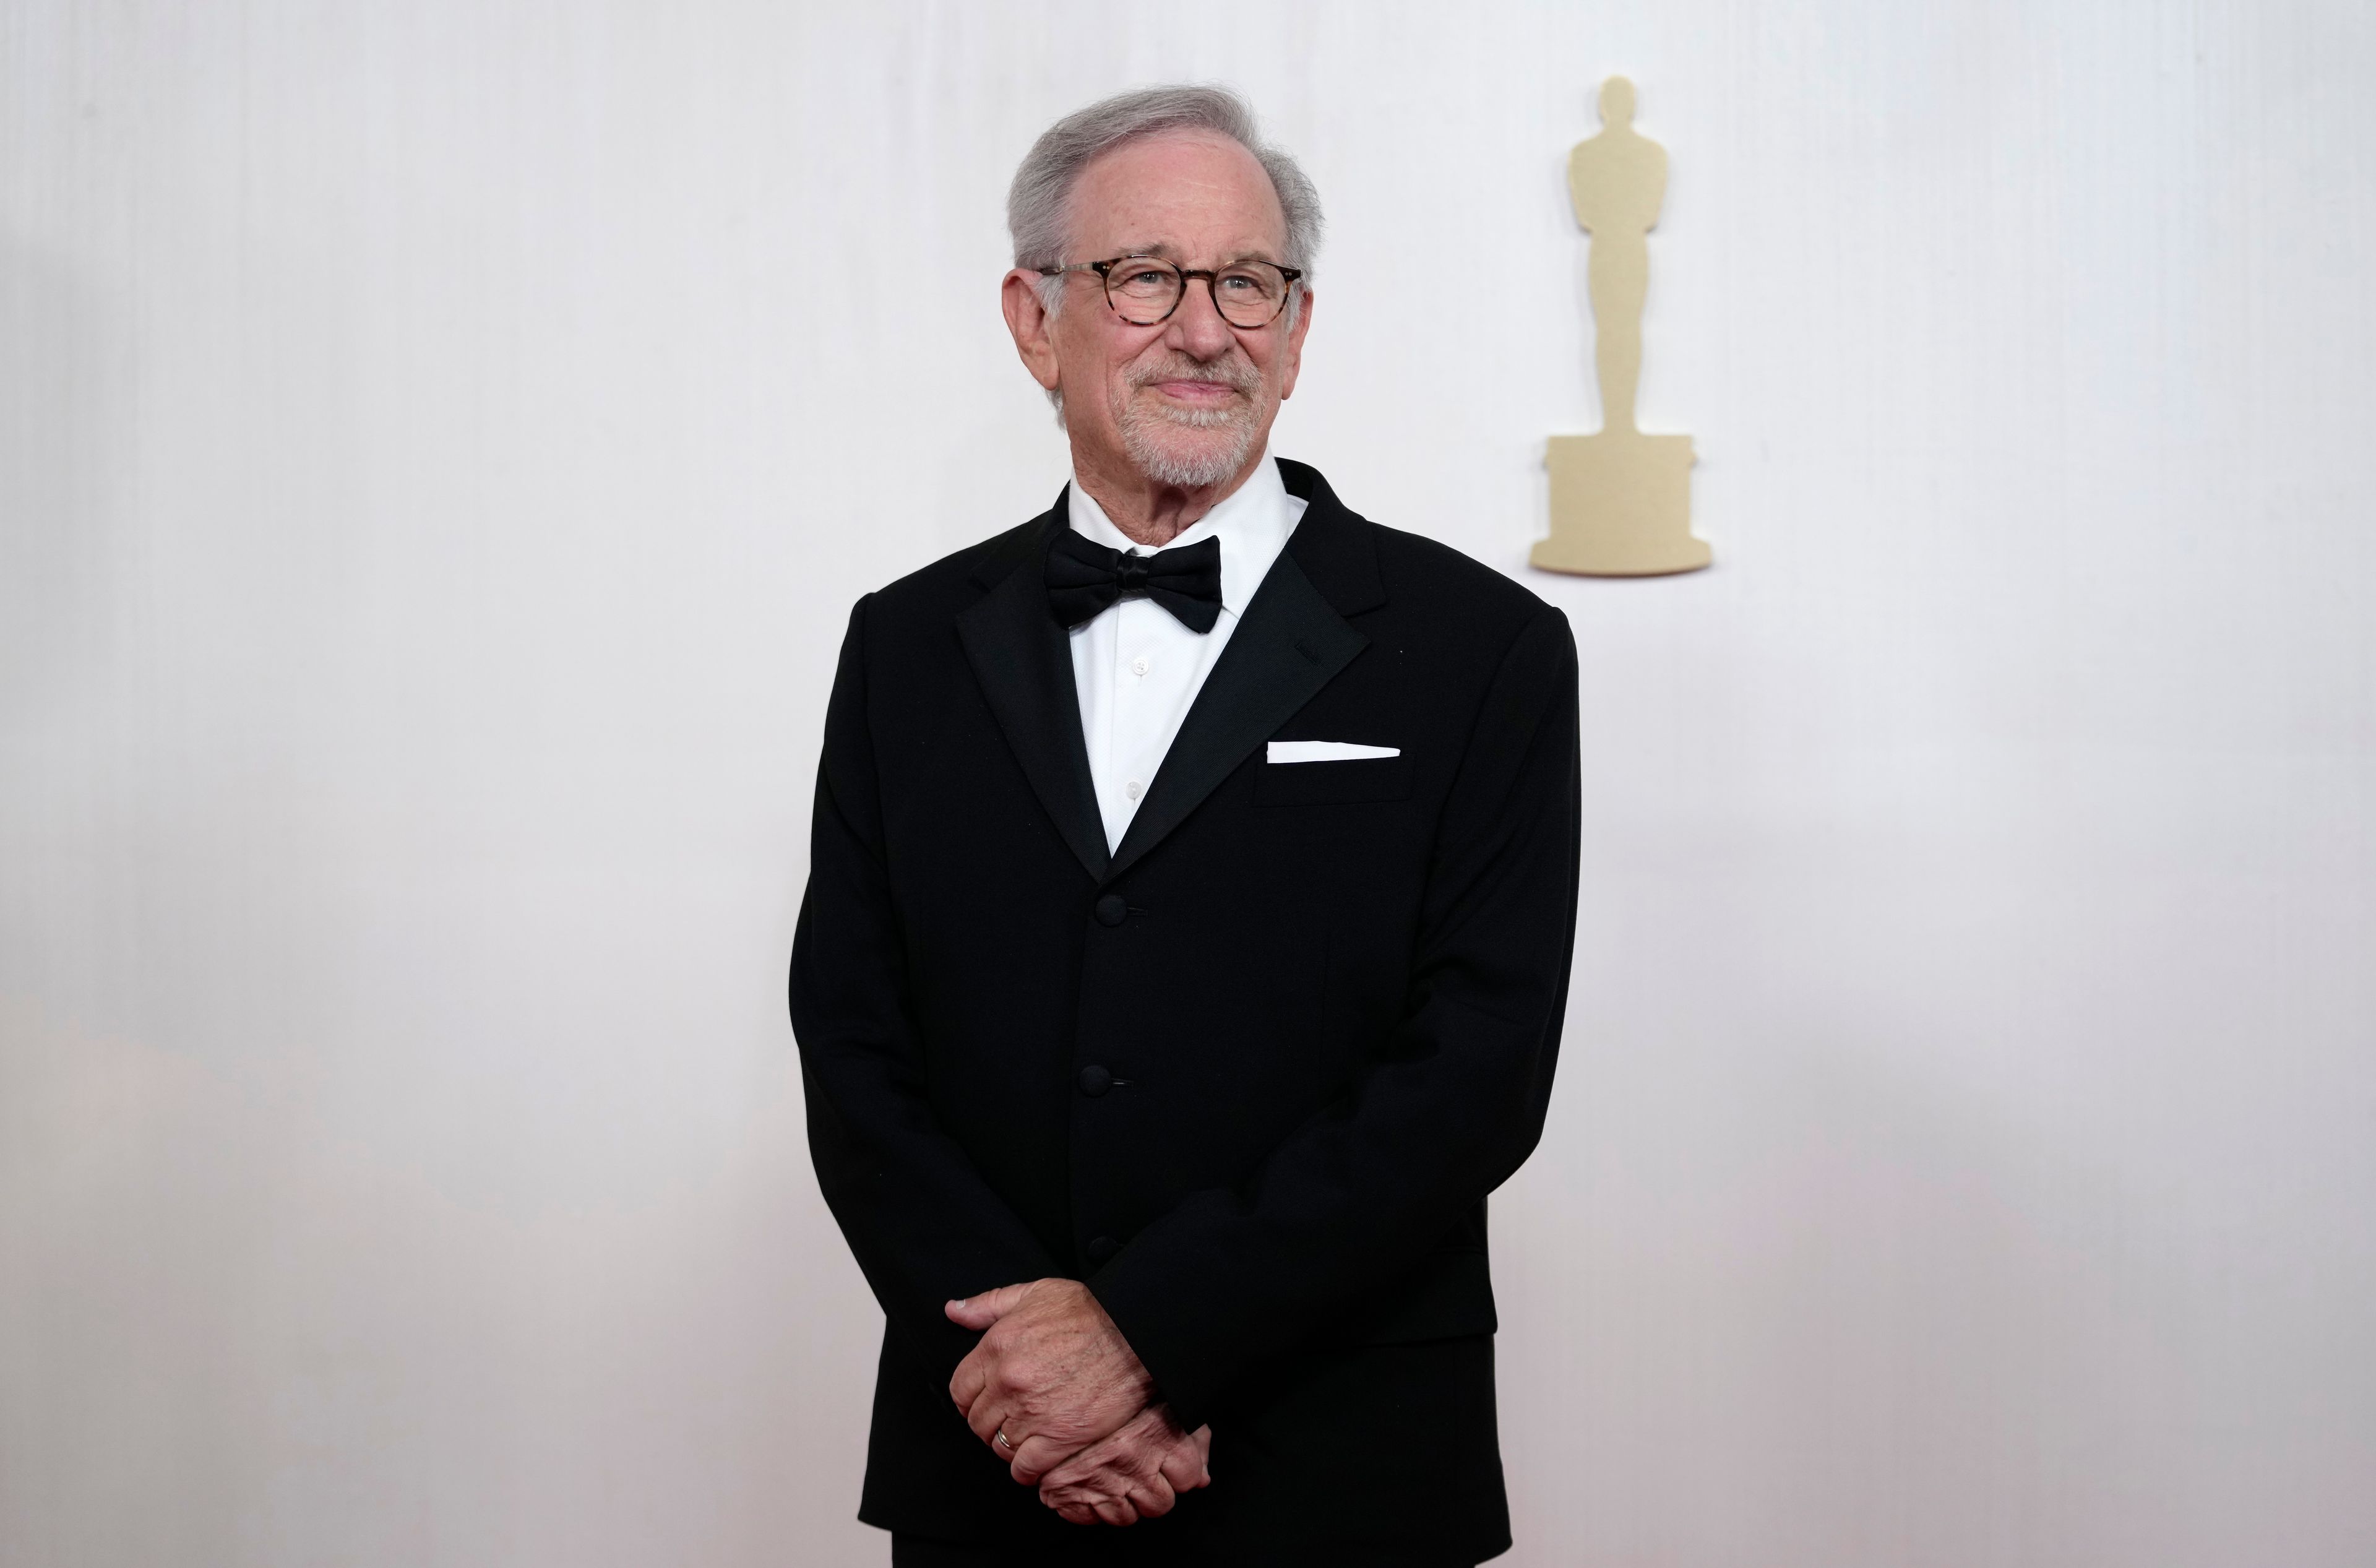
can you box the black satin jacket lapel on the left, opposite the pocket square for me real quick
[958,494,1107,879]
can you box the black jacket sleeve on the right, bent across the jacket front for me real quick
[1088,606,1580,1426]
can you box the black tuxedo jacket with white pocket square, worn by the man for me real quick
[791,463,1578,1563]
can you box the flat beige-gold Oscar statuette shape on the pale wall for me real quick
[1533,76,1711,577]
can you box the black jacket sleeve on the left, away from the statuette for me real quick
[791,599,1057,1381]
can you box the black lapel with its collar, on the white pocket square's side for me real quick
[1102,461,1385,881]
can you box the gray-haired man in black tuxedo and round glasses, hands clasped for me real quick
[791,88,1578,1568]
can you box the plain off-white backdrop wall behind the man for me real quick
[0,0,2376,1568]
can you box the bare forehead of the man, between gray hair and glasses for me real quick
[1069,131,1288,259]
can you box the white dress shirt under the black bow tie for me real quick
[1072,454,1304,851]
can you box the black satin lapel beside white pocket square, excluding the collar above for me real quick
[1112,541,1369,879]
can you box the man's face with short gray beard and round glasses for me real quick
[1005,131,1312,487]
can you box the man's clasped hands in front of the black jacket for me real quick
[945,1278,1212,1525]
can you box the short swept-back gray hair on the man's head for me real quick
[1007,85,1321,321]
